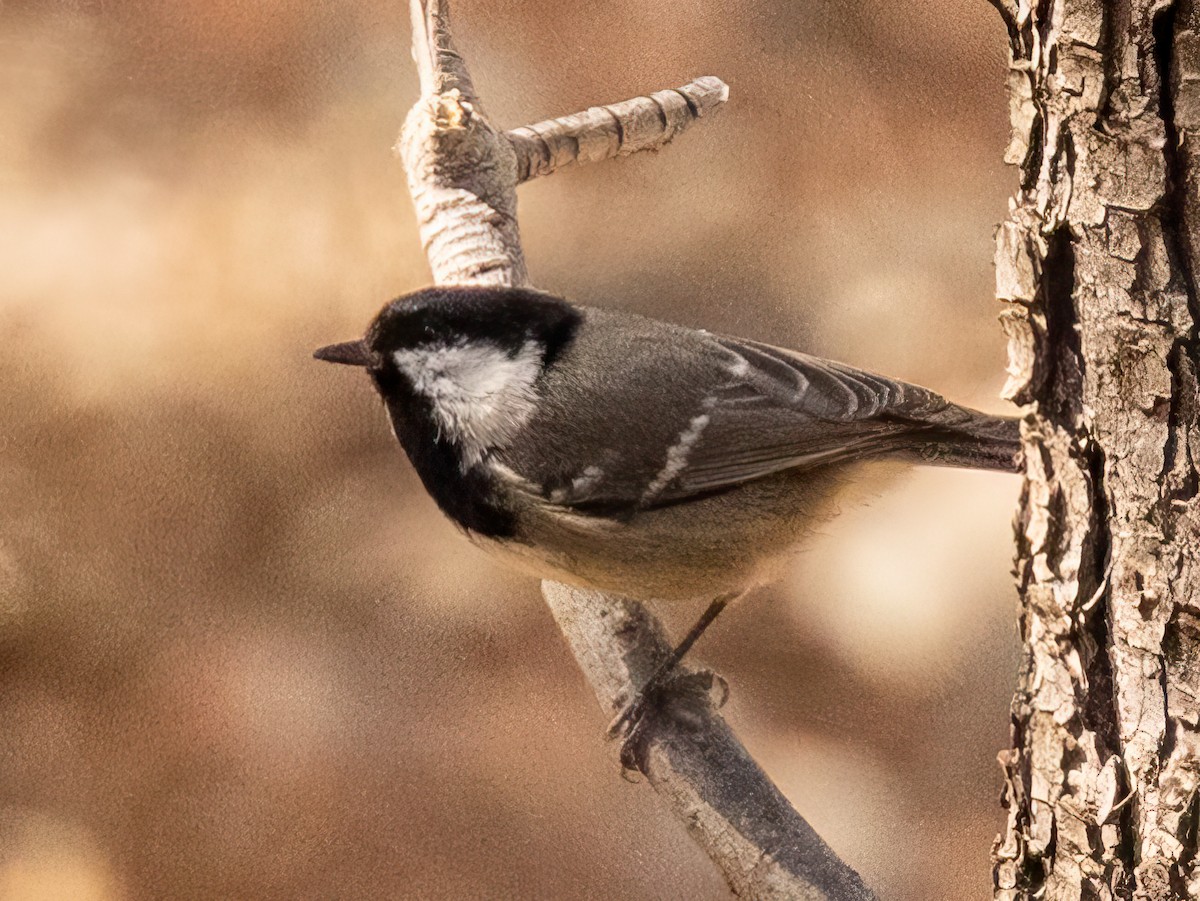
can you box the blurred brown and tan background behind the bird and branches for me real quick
[0,0,1019,901]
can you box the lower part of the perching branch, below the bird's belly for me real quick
[542,582,874,901]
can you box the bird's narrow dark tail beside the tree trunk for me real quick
[906,407,1022,473]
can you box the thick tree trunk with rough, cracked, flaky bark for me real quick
[992,0,1200,900]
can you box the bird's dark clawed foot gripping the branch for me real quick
[607,667,730,771]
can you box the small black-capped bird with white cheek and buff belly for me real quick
[314,287,1020,739]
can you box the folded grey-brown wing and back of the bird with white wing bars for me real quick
[499,310,971,516]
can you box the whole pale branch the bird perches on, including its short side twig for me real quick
[397,0,874,901]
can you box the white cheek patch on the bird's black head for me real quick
[392,341,542,465]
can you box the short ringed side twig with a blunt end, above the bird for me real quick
[506,76,730,181]
